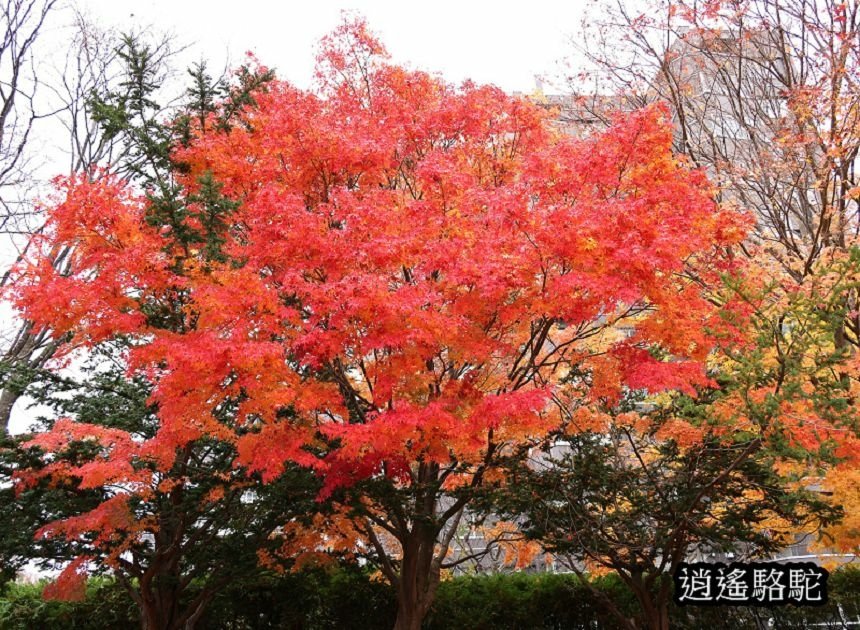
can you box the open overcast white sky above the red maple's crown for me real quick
[69,0,587,93]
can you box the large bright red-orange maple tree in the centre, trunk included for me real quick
[10,21,746,629]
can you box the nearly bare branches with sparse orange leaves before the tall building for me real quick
[576,0,860,268]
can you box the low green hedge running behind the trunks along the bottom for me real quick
[5,569,860,630]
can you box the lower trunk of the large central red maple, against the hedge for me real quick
[394,526,439,630]
